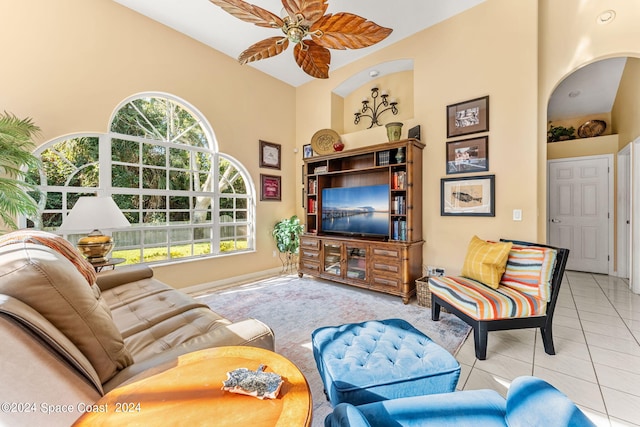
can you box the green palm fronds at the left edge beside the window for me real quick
[0,112,40,230]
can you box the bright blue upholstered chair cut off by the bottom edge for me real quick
[325,377,595,427]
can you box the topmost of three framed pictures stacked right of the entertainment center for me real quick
[447,96,489,138]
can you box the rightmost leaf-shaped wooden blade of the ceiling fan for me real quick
[309,13,393,49]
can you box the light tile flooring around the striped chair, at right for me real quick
[457,271,640,426]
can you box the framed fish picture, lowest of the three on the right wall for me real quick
[440,175,496,216]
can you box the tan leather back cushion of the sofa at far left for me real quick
[0,239,133,382]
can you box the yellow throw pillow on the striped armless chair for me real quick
[462,236,513,289]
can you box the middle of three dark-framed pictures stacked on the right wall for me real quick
[447,136,489,175]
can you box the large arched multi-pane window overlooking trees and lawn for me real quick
[28,94,255,263]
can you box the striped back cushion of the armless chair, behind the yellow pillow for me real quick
[500,244,557,301]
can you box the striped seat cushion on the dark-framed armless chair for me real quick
[429,276,547,320]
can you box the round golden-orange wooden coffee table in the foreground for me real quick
[74,346,312,427]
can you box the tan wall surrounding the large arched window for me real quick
[0,0,299,287]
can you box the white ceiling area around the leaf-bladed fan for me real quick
[113,0,485,86]
